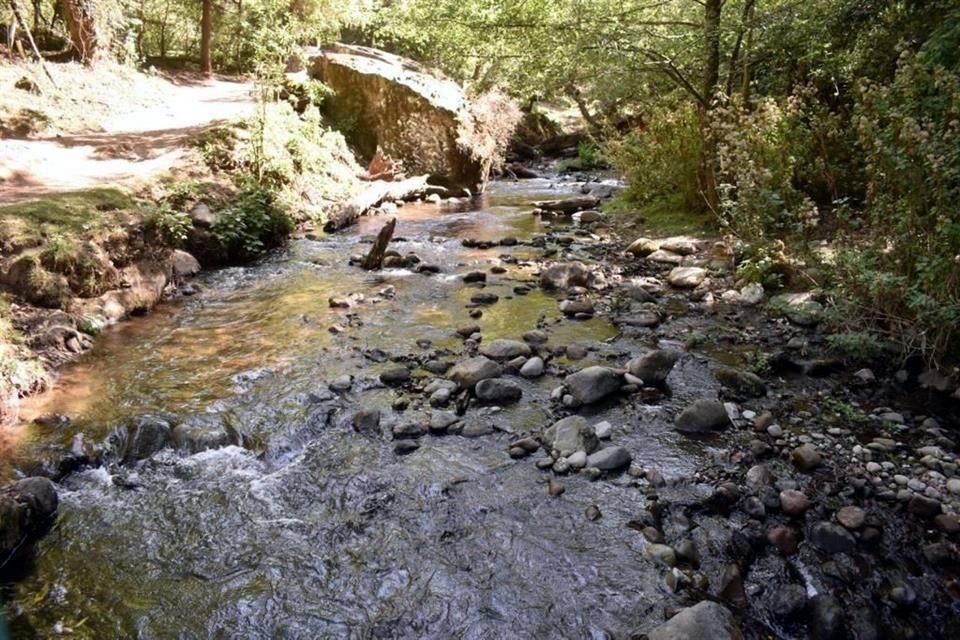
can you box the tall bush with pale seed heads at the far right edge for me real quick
[836,52,960,359]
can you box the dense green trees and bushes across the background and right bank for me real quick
[7,0,960,361]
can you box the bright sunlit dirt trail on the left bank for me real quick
[0,79,255,203]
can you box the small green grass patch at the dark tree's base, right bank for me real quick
[604,194,720,238]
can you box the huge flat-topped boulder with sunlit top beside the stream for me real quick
[309,44,520,193]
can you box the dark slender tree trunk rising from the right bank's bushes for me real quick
[699,0,724,211]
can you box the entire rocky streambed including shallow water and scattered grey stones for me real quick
[1,180,960,639]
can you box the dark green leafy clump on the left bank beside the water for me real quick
[213,186,293,261]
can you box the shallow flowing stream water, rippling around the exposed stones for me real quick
[0,181,713,638]
